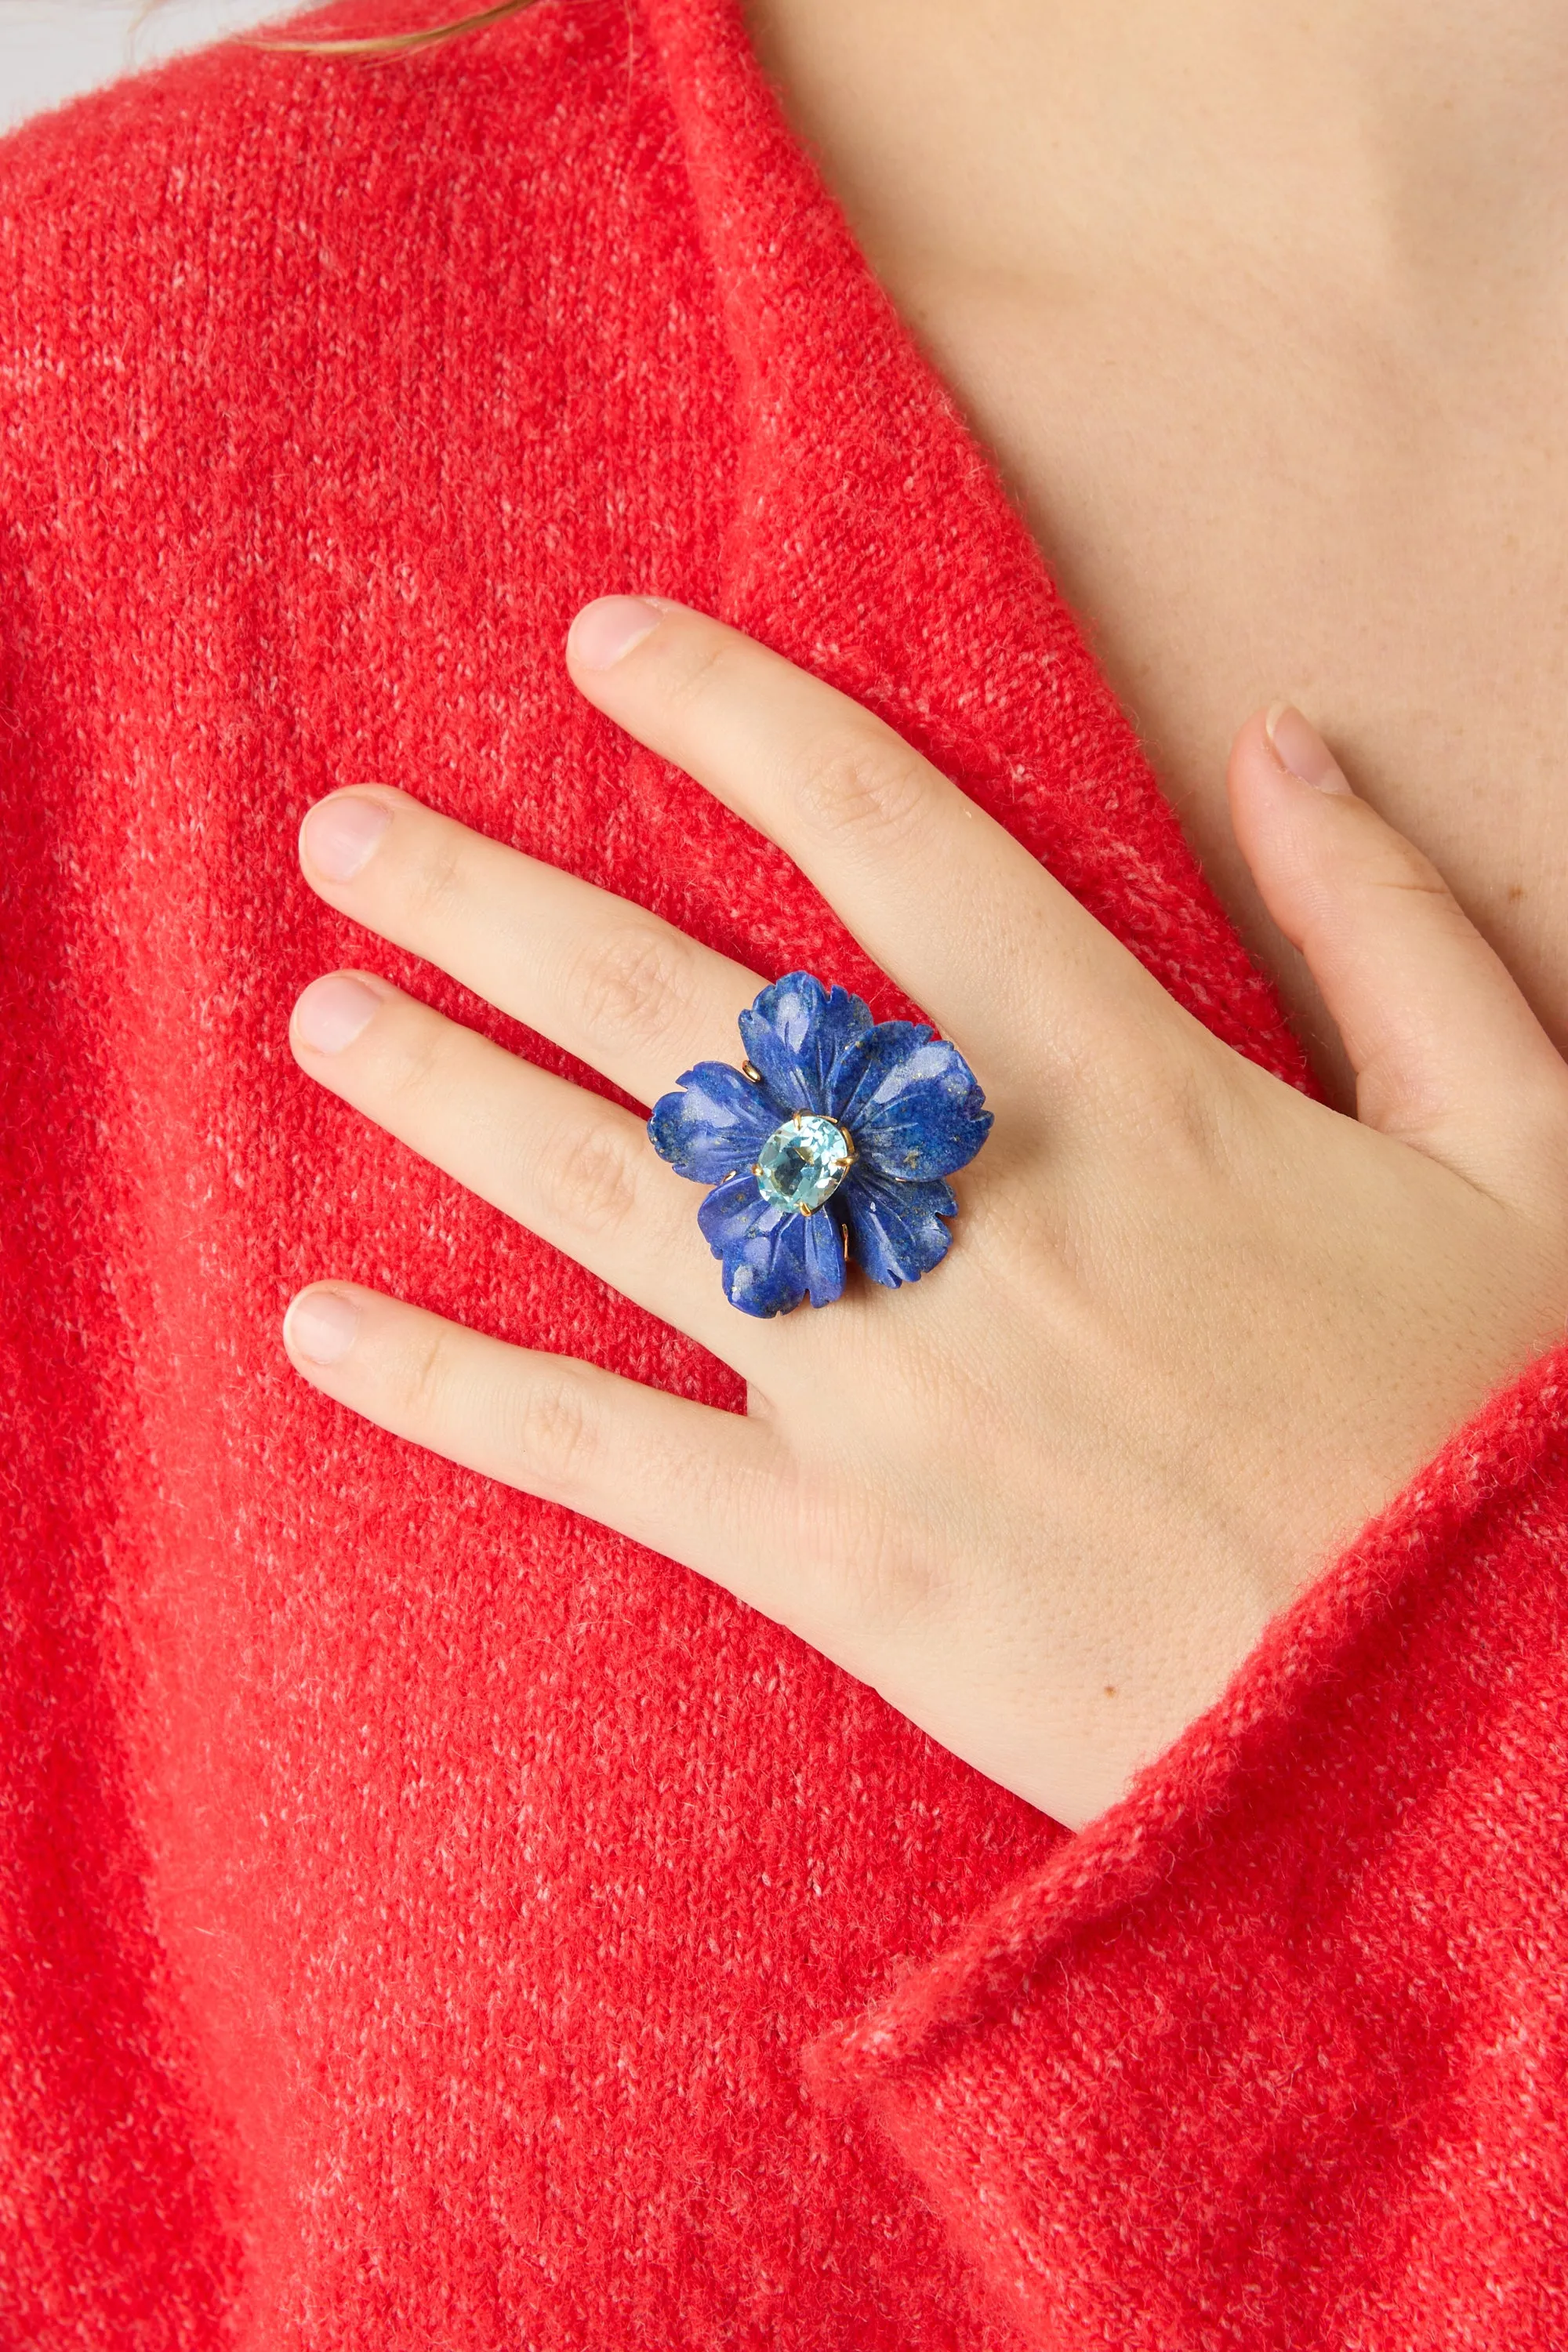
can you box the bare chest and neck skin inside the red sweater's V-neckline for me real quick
[748,0,1568,1103]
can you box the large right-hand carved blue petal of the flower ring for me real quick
[827,1021,992,1183]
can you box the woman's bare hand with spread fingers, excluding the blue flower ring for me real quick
[285,597,1568,1825]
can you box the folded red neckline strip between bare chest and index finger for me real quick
[640,0,1316,1091]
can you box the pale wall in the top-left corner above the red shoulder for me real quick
[0,0,296,134]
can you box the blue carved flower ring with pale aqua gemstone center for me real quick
[649,971,992,1315]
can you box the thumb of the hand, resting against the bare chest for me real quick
[1227,703,1568,1192]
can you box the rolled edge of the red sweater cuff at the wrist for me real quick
[801,1345,1568,2107]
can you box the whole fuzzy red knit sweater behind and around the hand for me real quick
[0,0,1568,2352]
